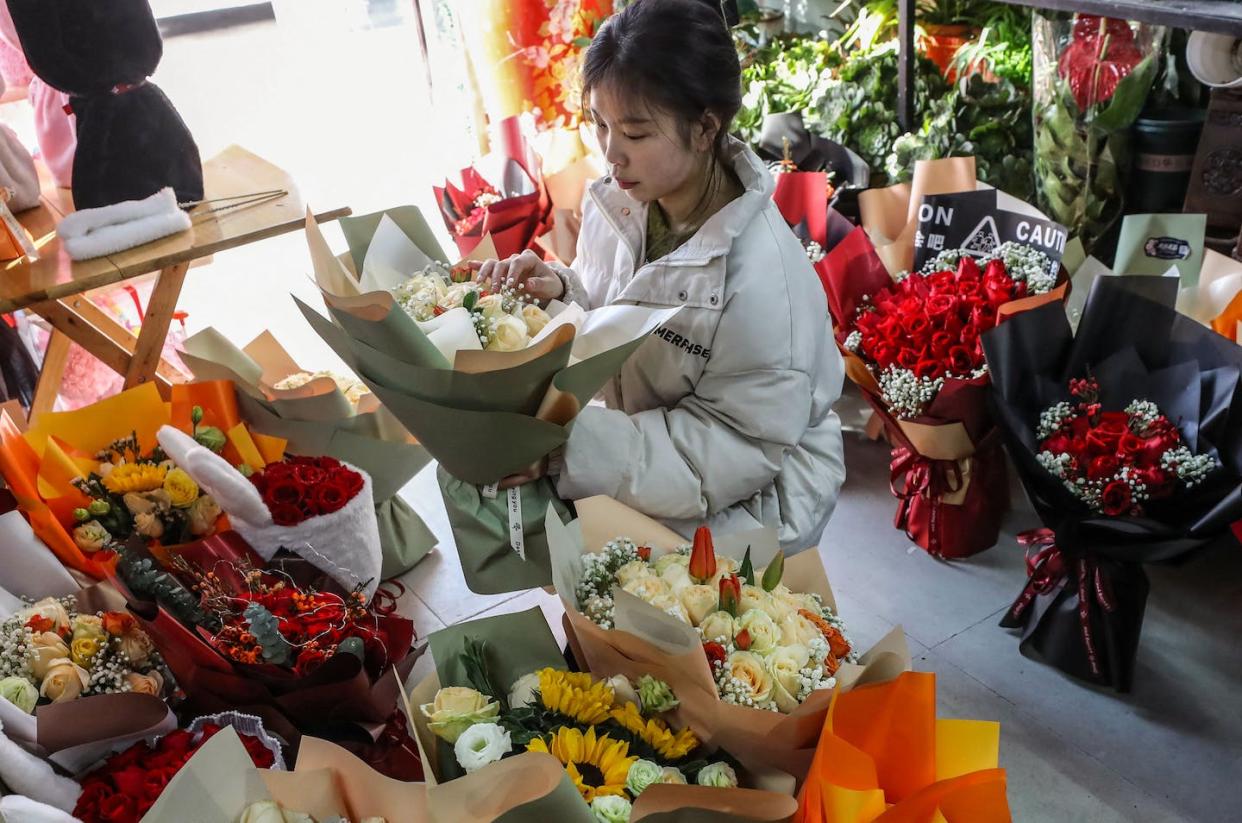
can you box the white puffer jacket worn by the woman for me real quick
[558,140,845,552]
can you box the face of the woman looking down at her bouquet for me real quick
[590,87,712,202]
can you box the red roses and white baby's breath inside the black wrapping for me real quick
[1035,377,1220,518]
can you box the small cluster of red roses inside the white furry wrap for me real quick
[250,457,365,526]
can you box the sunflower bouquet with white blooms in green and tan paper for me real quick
[410,608,792,823]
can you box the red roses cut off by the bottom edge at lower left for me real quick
[73,722,279,823]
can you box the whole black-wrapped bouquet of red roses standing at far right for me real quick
[984,277,1242,691]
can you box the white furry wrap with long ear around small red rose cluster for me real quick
[158,426,383,600]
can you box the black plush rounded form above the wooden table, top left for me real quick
[7,0,202,209]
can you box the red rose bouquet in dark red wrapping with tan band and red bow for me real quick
[825,228,1063,557]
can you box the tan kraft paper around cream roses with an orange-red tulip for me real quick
[546,498,910,776]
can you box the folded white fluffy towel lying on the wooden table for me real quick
[56,187,190,259]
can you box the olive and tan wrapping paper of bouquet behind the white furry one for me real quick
[183,329,436,580]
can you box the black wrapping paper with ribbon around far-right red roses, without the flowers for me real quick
[984,277,1242,691]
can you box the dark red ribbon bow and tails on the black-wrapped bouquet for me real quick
[1010,529,1117,678]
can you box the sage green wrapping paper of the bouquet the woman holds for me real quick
[294,209,677,593]
